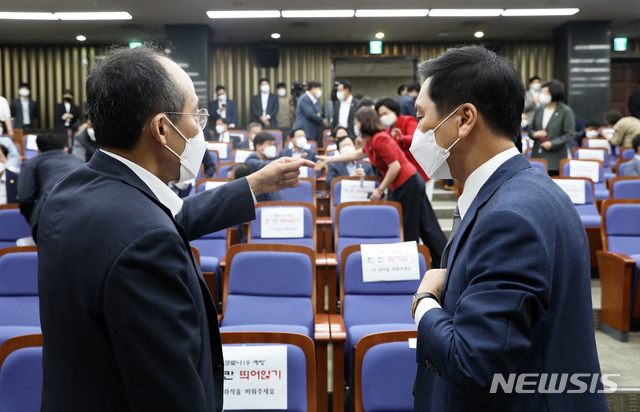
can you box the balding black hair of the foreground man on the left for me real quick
[87,46,186,150]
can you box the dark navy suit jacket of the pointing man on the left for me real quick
[38,152,255,412]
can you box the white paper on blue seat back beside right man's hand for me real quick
[360,241,420,282]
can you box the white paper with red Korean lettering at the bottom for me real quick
[222,345,288,410]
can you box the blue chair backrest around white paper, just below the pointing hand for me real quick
[247,202,318,250]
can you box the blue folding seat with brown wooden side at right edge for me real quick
[597,199,640,342]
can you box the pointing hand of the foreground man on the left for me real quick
[247,157,315,196]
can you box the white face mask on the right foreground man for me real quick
[409,105,462,179]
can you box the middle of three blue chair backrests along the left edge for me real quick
[0,246,38,297]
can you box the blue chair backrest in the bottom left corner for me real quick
[0,334,42,412]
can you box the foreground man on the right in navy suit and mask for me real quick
[412,46,608,412]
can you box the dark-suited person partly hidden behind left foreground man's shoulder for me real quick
[18,133,82,240]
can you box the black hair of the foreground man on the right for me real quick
[418,46,525,141]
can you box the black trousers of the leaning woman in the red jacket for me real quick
[391,172,447,268]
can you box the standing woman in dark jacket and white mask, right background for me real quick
[529,80,576,176]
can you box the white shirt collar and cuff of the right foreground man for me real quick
[415,147,520,326]
